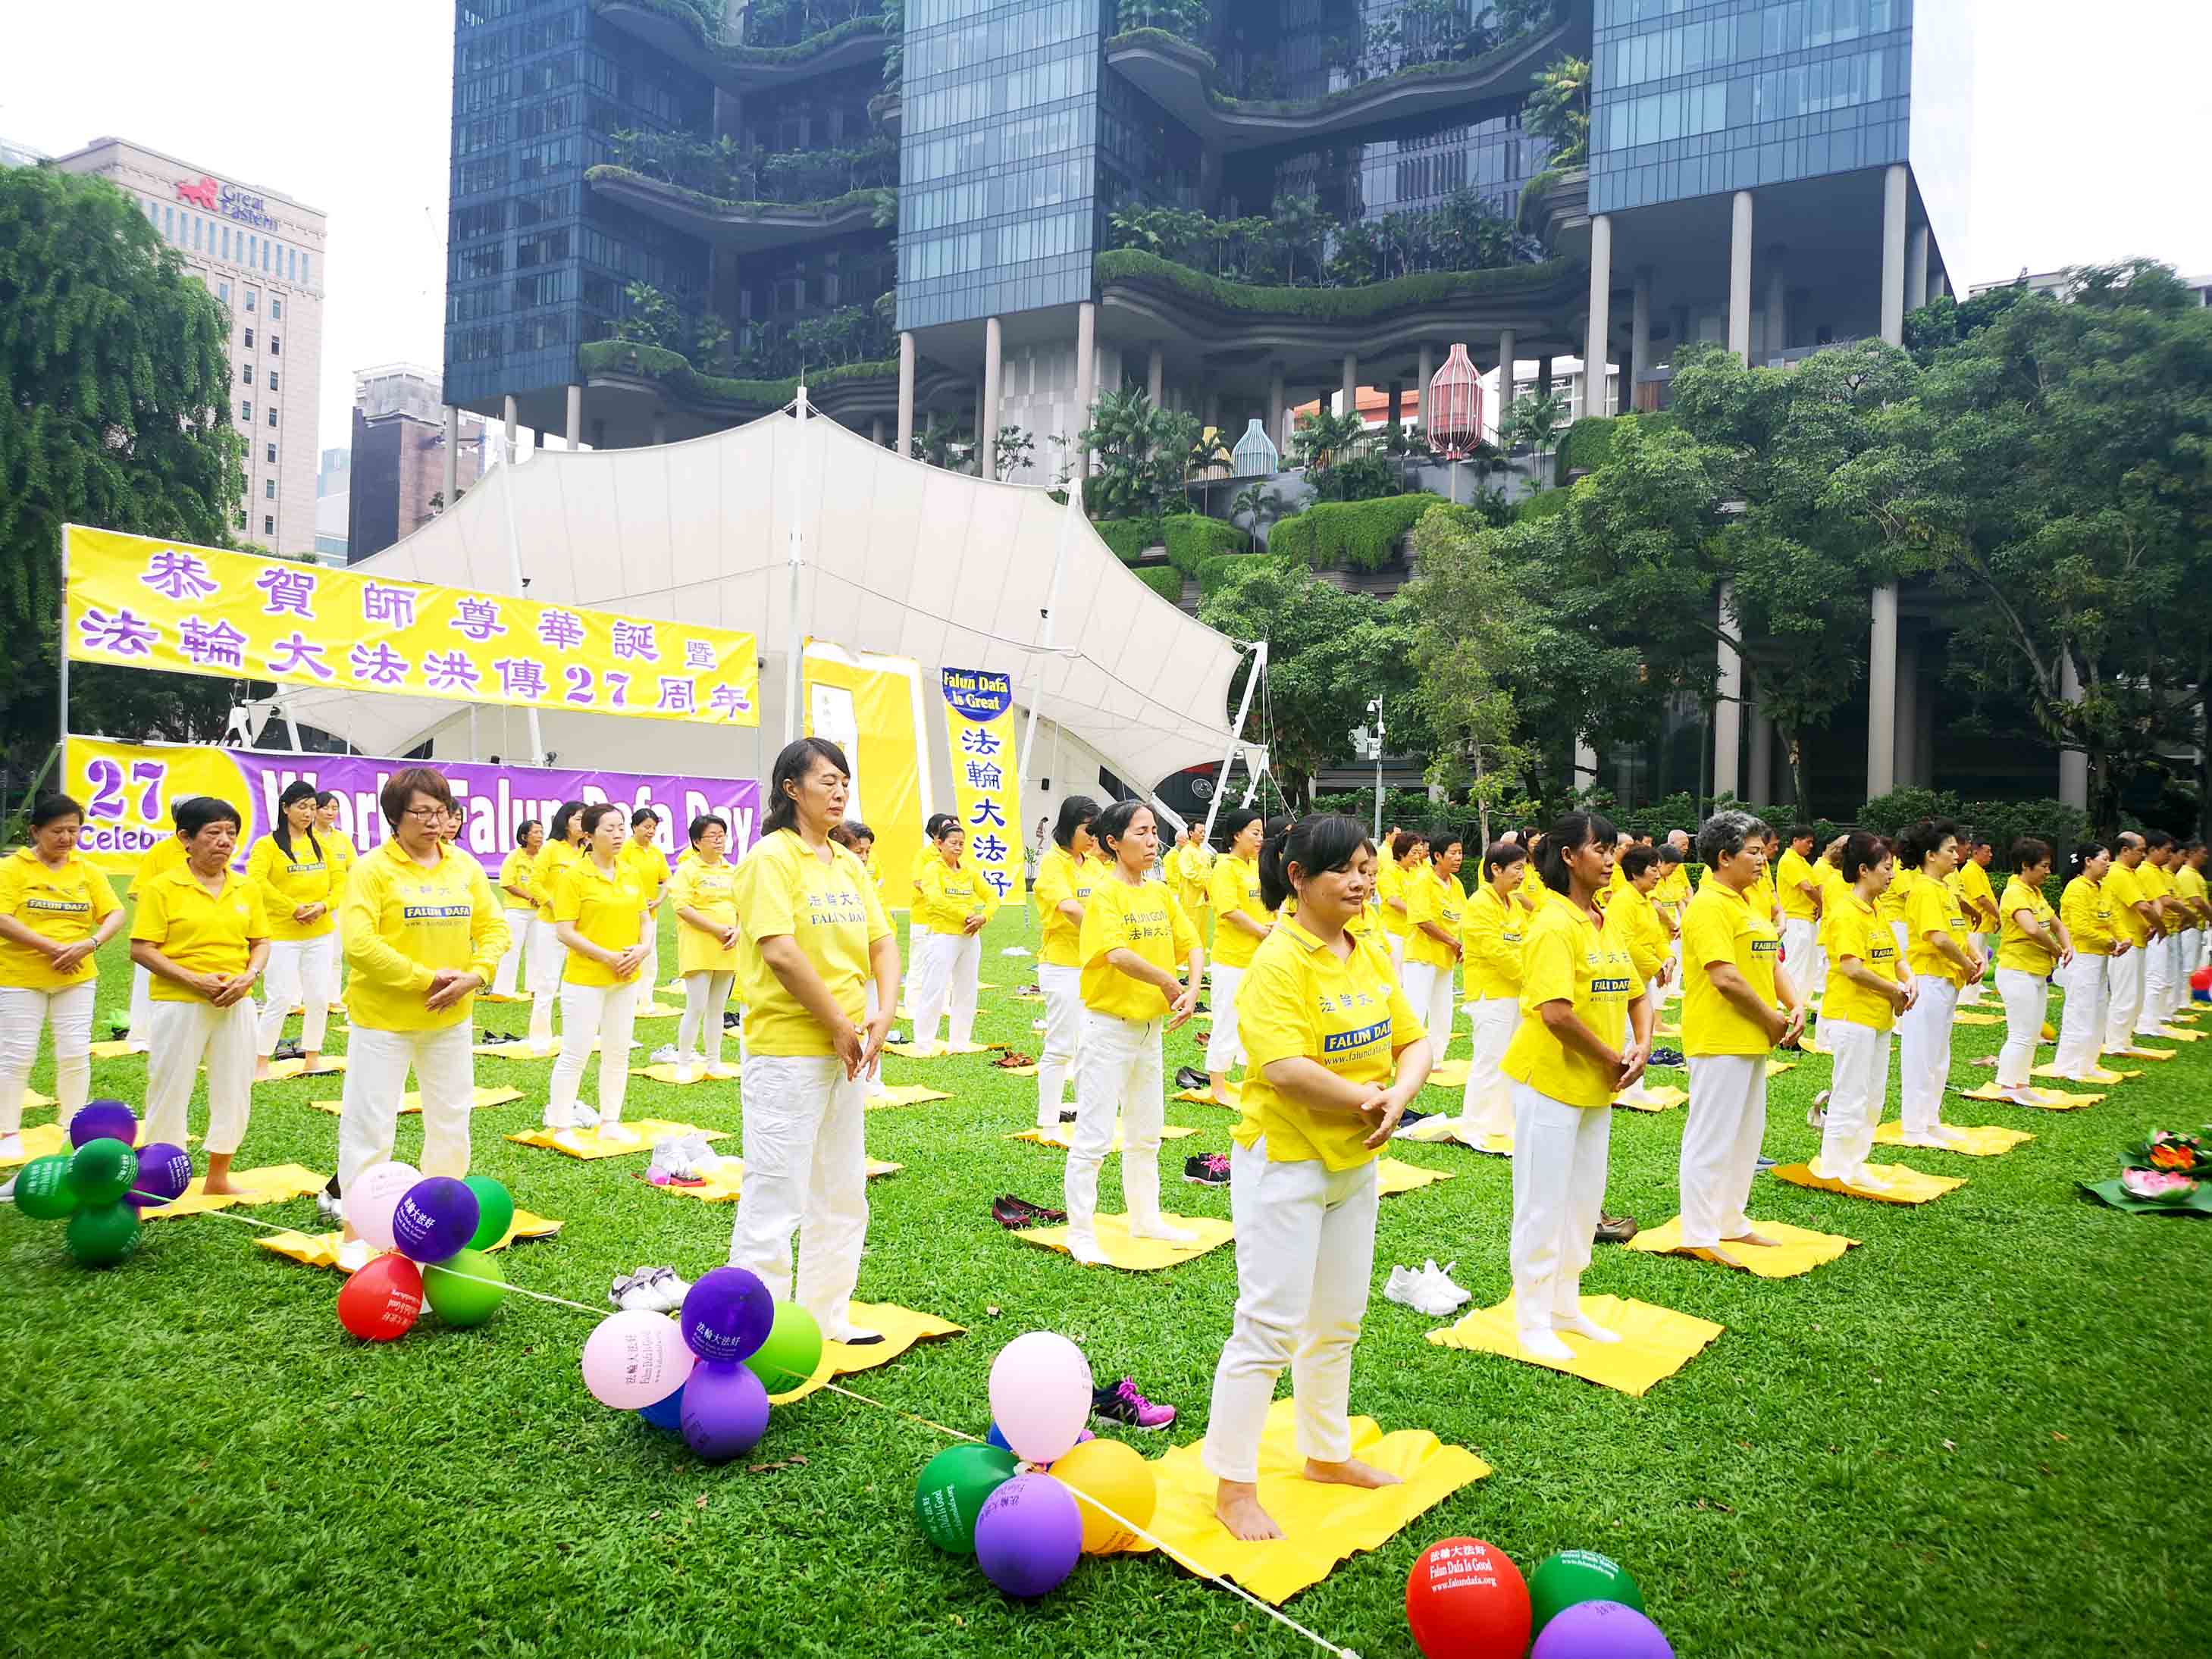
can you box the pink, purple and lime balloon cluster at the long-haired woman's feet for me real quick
[584,1267,822,1462]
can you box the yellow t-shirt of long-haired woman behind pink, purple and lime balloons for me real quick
[730,830,893,1055]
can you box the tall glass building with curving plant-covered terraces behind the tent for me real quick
[445,0,1991,818]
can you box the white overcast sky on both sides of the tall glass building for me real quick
[0,0,2212,464]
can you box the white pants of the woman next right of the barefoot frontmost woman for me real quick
[1511,1084,1612,1332]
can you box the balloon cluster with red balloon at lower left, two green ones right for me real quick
[338,1163,515,1343]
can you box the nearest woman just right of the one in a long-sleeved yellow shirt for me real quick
[544,801,653,1148]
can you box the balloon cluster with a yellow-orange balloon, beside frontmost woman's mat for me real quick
[913,1332,1159,1595]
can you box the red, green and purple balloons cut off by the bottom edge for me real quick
[1405,1537,1675,1659]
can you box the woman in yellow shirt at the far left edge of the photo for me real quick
[0,794,123,1163]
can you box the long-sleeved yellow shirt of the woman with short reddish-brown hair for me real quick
[338,840,511,1031]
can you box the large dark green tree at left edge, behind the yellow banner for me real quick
[0,168,246,765]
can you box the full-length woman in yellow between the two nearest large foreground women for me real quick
[1064,801,1221,1267]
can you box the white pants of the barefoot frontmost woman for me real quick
[1201,1139,1378,1480]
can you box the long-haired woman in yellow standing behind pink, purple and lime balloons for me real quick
[730,737,898,1345]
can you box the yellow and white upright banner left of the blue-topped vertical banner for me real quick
[801,639,931,909]
